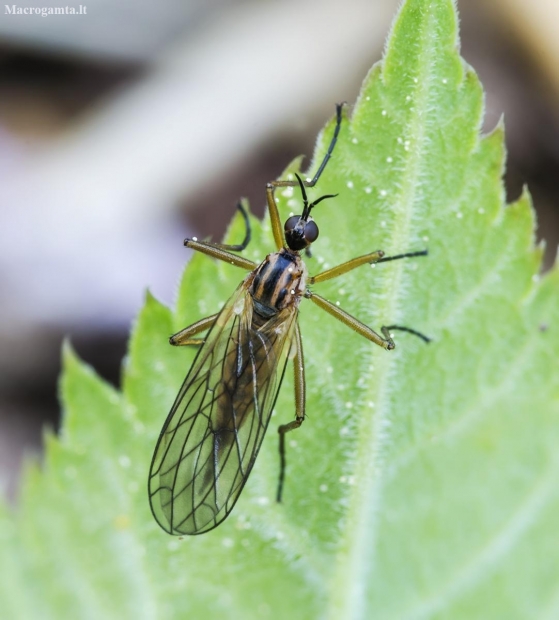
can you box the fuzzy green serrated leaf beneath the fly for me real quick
[0,0,559,620]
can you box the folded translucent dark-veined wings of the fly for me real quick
[149,276,297,535]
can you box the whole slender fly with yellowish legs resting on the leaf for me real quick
[148,105,429,535]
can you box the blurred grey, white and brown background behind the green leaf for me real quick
[0,0,559,499]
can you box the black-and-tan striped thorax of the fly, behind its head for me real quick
[250,249,307,318]
